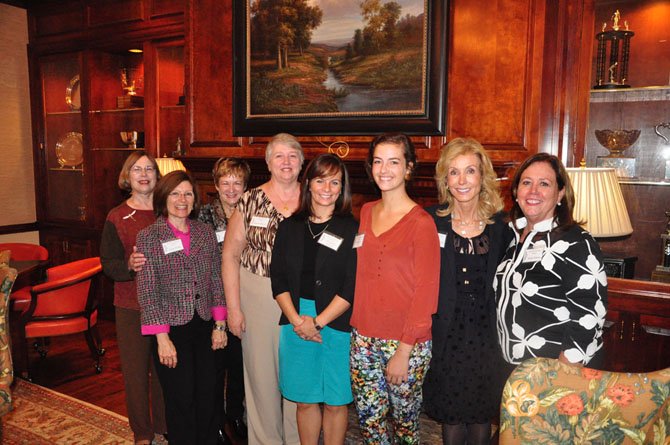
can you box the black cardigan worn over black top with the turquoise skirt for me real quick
[270,215,358,332]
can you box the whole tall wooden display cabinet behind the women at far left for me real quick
[28,0,187,315]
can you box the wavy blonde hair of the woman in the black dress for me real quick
[435,138,505,223]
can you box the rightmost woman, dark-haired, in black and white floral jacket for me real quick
[494,153,607,366]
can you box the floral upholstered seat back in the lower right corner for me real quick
[500,358,670,445]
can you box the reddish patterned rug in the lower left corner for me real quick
[2,379,133,445]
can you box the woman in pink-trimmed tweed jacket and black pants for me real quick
[137,170,227,445]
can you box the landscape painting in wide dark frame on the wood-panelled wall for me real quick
[233,0,448,136]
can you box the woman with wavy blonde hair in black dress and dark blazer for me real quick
[423,138,512,445]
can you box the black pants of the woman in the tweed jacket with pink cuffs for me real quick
[153,315,219,445]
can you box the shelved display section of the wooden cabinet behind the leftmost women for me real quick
[35,39,186,251]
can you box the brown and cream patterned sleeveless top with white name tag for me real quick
[237,187,285,278]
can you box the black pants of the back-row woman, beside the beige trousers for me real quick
[216,333,244,429]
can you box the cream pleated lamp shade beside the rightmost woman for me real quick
[566,167,633,238]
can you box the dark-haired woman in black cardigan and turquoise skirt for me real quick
[270,154,358,445]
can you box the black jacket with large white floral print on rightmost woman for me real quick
[493,218,607,364]
